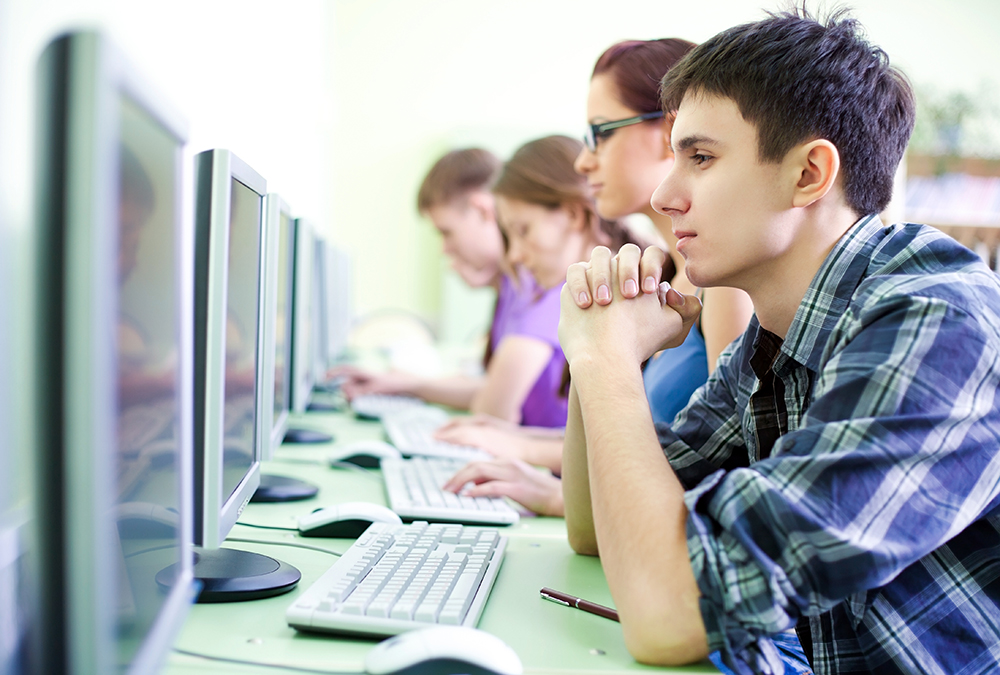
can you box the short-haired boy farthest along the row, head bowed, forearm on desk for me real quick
[330,148,565,427]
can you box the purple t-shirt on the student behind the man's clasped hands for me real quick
[490,273,568,427]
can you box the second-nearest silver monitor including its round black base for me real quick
[186,149,300,602]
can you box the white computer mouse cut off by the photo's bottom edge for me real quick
[365,626,524,675]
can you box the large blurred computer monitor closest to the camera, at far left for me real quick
[32,32,195,673]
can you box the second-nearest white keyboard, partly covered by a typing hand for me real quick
[381,457,520,525]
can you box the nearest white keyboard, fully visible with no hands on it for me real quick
[285,522,507,635]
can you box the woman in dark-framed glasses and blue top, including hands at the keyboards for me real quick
[438,38,753,476]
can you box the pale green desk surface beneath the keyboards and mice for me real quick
[164,413,718,675]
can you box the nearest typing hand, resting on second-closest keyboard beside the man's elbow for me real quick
[443,459,564,516]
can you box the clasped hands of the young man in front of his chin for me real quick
[559,244,701,367]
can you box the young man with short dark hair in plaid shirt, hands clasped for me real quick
[560,6,1000,673]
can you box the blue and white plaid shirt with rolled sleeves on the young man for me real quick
[658,216,1000,674]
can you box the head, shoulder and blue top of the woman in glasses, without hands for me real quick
[576,39,753,422]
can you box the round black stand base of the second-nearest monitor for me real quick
[156,546,302,603]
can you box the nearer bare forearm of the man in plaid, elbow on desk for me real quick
[566,358,707,665]
